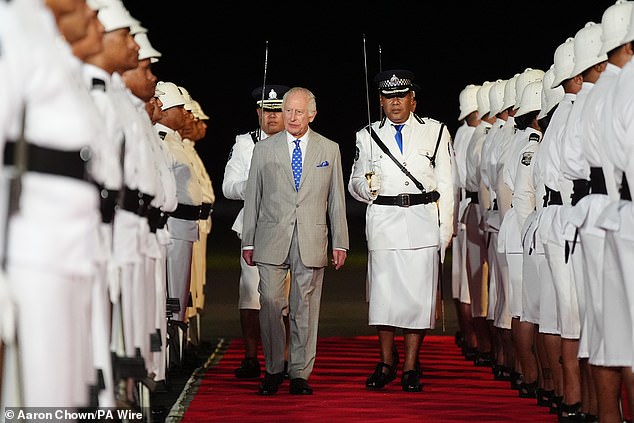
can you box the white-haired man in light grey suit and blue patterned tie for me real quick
[242,87,348,395]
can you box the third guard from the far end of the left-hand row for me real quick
[154,82,202,365]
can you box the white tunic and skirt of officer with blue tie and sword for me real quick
[348,114,454,329]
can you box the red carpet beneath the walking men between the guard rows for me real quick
[181,336,557,423]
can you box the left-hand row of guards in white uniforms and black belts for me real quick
[0,0,215,419]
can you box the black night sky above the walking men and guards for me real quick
[124,0,614,215]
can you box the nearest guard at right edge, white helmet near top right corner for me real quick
[571,0,634,421]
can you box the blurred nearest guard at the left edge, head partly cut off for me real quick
[0,1,104,408]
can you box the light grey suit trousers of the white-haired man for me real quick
[257,225,324,379]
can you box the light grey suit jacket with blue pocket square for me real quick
[242,130,348,267]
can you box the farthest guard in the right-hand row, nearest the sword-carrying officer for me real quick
[451,84,480,360]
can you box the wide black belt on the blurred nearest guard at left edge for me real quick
[4,141,91,181]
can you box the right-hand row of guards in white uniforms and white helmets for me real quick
[452,0,634,423]
